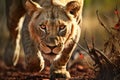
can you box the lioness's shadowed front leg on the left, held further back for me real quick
[23,35,44,72]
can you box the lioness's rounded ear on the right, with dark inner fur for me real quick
[66,1,81,17]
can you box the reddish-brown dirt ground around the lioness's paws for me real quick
[0,57,95,80]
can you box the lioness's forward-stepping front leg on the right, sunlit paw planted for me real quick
[50,44,75,80]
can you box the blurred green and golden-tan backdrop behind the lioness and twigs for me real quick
[0,0,120,59]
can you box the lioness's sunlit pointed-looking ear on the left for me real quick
[25,0,41,15]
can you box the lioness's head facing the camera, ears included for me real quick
[26,0,82,59]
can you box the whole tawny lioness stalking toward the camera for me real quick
[5,0,83,79]
